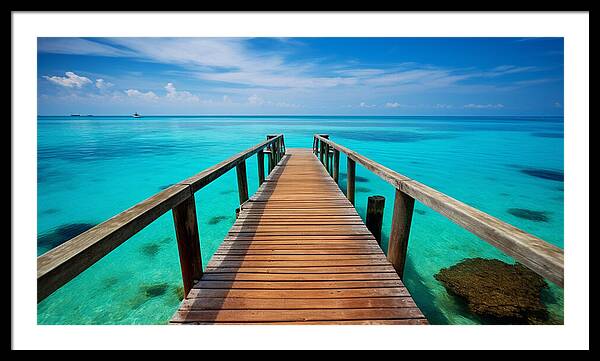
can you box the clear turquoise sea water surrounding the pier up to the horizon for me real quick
[37,116,564,324]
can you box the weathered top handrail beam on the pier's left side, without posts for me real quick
[37,134,285,302]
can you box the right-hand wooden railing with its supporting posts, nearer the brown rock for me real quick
[313,134,564,287]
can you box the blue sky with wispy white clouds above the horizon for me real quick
[38,38,564,115]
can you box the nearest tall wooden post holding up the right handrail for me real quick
[387,189,415,279]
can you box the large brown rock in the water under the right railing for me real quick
[434,258,549,324]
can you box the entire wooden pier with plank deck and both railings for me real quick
[38,134,564,324]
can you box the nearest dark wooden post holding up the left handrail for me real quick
[173,194,202,297]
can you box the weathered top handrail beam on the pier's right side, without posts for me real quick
[314,134,564,287]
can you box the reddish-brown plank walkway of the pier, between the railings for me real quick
[171,149,427,324]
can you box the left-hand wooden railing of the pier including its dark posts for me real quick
[37,134,285,302]
